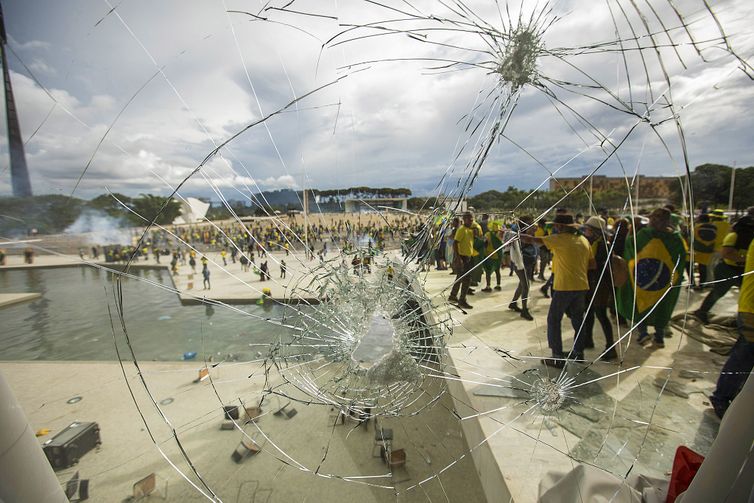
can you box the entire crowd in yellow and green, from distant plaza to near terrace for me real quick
[0,205,754,417]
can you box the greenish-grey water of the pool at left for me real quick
[0,267,291,361]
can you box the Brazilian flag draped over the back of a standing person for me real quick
[616,227,686,327]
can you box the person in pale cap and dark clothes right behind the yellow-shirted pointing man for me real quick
[582,217,618,361]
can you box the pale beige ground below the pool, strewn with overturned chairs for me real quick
[0,362,484,502]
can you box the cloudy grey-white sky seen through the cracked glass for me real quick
[0,0,754,199]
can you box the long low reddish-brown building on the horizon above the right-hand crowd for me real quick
[550,175,678,199]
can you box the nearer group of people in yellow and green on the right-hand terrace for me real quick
[440,205,754,417]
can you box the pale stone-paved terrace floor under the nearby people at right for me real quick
[426,266,736,501]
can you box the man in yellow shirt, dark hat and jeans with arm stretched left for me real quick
[521,212,593,368]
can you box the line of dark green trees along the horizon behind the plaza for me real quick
[0,164,740,236]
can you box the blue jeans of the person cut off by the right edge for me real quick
[710,313,754,416]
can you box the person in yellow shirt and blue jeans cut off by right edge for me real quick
[710,241,754,419]
